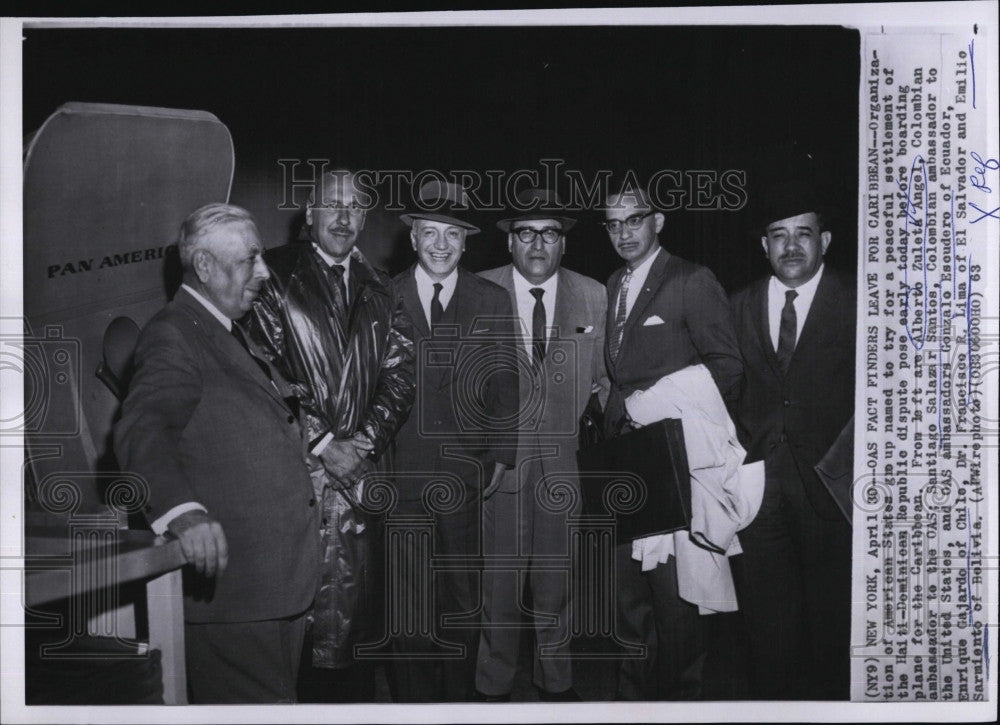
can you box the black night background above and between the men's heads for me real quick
[23,27,859,290]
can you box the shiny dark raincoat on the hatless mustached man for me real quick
[249,242,415,668]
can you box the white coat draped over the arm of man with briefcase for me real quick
[625,365,764,614]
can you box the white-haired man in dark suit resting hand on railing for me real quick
[115,204,319,703]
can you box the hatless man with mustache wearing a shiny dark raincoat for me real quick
[251,171,415,701]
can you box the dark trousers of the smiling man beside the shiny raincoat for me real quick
[387,489,482,702]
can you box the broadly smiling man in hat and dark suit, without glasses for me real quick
[389,181,518,702]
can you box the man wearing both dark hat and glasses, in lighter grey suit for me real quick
[476,189,608,701]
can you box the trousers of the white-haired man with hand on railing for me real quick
[184,612,306,705]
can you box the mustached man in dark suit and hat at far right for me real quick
[732,182,855,699]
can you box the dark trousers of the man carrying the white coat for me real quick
[615,542,708,700]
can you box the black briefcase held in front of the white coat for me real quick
[576,418,691,543]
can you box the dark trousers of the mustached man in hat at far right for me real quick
[733,444,851,700]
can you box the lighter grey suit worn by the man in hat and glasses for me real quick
[476,265,608,695]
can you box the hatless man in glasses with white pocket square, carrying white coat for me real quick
[604,187,742,700]
